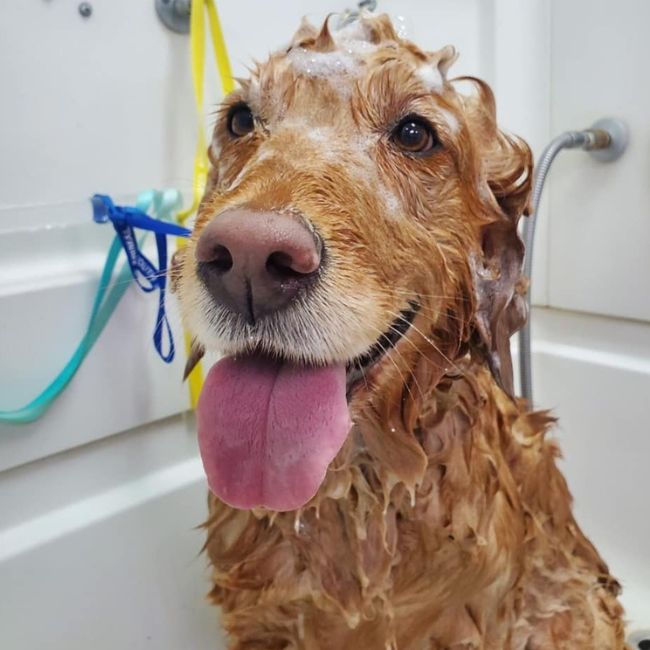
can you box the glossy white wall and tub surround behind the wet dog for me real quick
[0,0,650,650]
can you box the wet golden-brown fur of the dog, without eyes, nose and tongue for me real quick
[175,17,625,650]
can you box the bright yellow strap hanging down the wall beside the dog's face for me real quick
[176,0,234,408]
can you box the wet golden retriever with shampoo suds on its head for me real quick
[173,16,625,650]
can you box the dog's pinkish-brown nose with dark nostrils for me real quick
[195,208,322,323]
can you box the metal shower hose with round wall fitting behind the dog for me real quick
[519,117,624,400]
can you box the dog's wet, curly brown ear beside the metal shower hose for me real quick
[456,79,533,396]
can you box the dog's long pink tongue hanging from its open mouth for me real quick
[197,356,351,510]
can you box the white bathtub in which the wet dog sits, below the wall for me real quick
[0,304,650,650]
